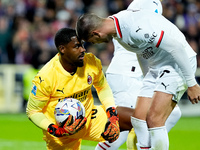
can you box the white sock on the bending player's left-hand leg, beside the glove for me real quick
[131,117,151,147]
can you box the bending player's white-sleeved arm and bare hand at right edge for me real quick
[156,30,200,104]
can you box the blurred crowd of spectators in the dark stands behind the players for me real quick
[0,0,200,67]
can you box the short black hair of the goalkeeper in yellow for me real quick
[54,28,77,48]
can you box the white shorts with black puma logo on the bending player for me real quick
[138,56,197,102]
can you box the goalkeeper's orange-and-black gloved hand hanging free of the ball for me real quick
[101,107,120,143]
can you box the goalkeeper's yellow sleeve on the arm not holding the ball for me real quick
[93,55,115,109]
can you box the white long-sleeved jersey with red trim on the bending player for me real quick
[111,10,196,86]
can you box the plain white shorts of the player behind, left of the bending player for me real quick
[106,73,143,108]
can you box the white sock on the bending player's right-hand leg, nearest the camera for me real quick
[149,126,169,150]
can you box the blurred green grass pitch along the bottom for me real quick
[0,114,200,150]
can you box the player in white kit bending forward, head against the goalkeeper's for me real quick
[76,2,200,150]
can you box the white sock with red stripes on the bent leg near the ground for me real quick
[95,131,129,150]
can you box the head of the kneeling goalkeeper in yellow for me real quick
[54,28,85,67]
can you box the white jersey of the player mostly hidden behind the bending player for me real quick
[106,0,162,77]
